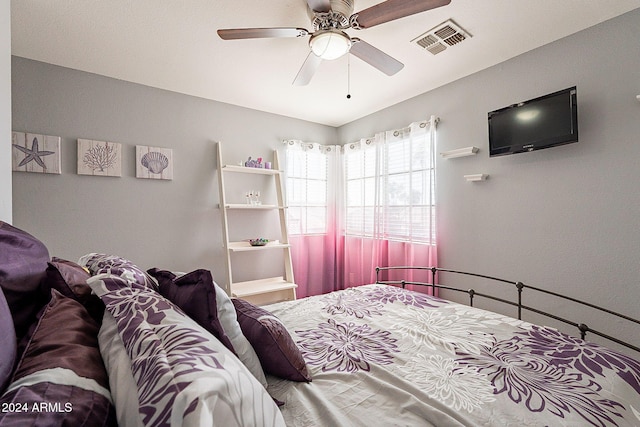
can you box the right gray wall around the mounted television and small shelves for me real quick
[339,9,640,352]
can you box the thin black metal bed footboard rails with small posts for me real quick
[376,266,640,353]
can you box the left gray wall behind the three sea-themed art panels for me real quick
[12,57,337,282]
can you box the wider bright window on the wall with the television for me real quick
[345,124,436,244]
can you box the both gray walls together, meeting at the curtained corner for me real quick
[12,10,640,352]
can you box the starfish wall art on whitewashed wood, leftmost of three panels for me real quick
[11,132,61,175]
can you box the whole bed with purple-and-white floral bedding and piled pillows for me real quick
[0,223,640,427]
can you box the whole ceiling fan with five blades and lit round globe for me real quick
[218,0,451,86]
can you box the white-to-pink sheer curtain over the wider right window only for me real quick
[344,117,438,298]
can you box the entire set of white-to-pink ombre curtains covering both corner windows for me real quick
[284,116,438,297]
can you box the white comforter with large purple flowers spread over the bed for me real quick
[265,285,640,427]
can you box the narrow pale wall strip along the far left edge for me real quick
[0,0,12,223]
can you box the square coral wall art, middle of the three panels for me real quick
[78,139,122,176]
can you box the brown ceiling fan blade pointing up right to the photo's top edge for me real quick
[351,0,451,29]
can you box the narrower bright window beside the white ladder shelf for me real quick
[286,145,328,235]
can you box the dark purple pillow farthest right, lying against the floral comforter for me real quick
[231,298,311,382]
